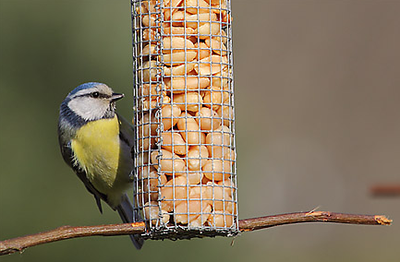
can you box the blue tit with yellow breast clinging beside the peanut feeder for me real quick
[58,82,143,249]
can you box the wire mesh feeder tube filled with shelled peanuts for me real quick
[132,0,239,239]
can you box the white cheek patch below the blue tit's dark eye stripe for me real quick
[68,97,108,121]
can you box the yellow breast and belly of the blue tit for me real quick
[71,116,120,194]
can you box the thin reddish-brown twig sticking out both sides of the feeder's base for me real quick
[0,211,392,255]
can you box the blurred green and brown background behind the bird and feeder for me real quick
[0,0,400,262]
